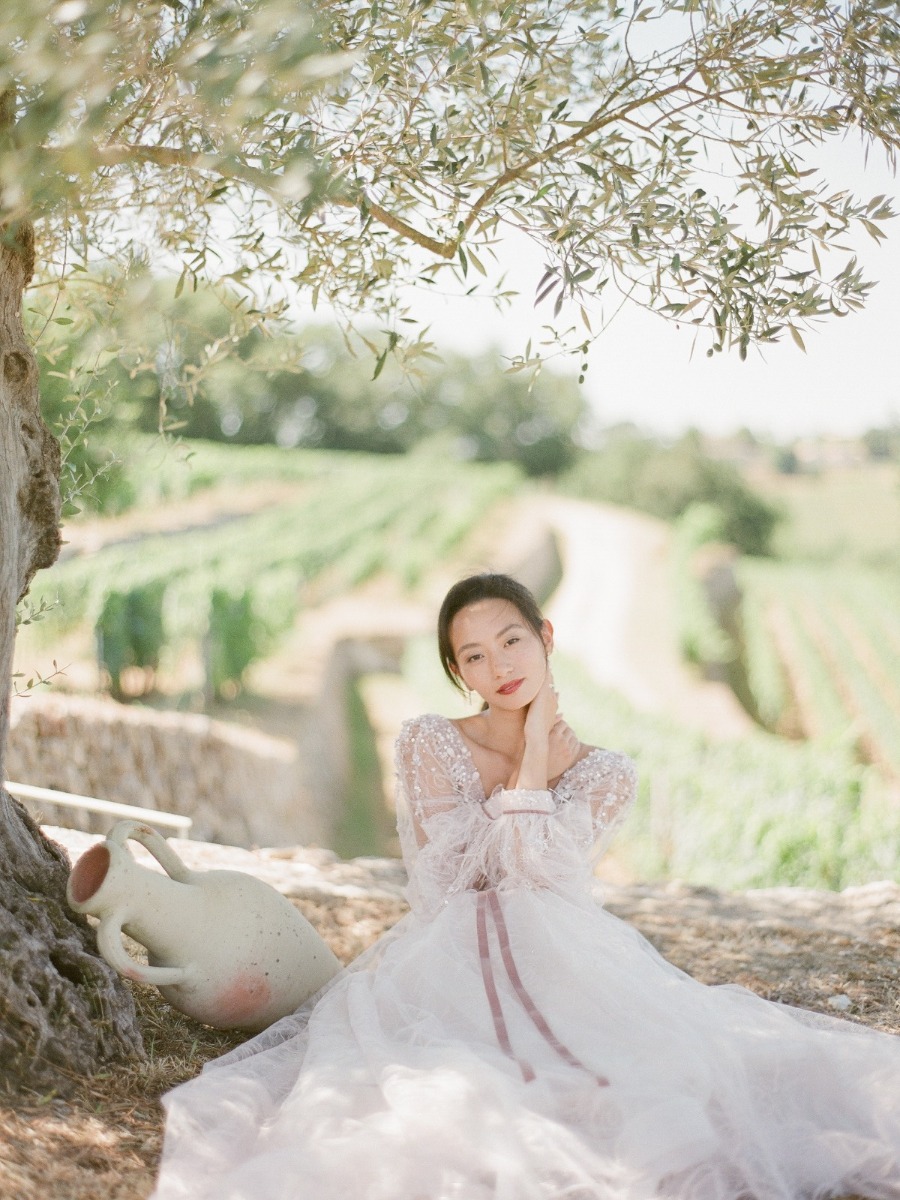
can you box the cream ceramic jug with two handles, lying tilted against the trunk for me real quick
[67,821,341,1033]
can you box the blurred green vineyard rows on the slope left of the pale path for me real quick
[32,452,520,695]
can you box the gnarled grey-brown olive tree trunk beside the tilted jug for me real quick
[0,224,143,1091]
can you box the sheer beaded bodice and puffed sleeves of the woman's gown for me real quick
[396,713,636,916]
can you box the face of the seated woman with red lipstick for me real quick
[450,600,553,710]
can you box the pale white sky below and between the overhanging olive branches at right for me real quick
[398,142,900,439]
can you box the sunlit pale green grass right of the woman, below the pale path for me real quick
[553,654,900,888]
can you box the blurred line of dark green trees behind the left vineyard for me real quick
[37,275,588,472]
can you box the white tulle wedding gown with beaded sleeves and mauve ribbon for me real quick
[154,715,900,1200]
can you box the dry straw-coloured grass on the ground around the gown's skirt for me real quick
[0,900,900,1200]
